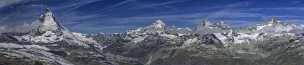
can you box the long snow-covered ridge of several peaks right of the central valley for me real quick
[122,18,303,47]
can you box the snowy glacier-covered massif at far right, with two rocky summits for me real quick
[197,17,303,47]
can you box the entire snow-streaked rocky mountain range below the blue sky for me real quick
[0,9,304,65]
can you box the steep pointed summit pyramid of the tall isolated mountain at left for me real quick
[36,8,64,33]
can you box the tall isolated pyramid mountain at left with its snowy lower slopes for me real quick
[15,9,97,47]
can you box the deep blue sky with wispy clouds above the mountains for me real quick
[0,0,304,32]
